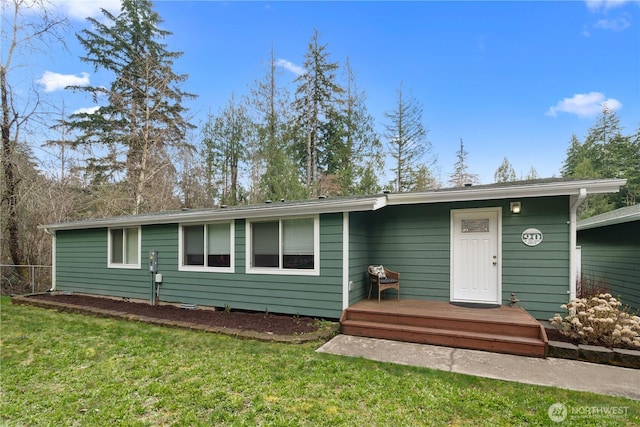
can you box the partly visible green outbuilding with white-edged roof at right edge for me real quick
[577,204,640,311]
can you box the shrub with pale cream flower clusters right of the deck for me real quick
[549,293,640,349]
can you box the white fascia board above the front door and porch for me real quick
[387,179,626,205]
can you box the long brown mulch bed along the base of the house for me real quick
[29,294,322,336]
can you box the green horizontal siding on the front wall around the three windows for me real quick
[57,214,342,318]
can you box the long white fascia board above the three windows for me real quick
[40,196,386,231]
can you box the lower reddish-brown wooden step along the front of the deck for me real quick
[342,320,546,357]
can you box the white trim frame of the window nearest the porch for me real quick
[245,215,320,276]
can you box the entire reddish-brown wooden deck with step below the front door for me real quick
[340,300,547,357]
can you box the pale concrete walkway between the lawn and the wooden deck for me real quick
[317,335,640,400]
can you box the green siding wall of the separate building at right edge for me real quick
[578,221,640,311]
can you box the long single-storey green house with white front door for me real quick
[43,179,625,319]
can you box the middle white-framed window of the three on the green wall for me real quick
[180,223,233,272]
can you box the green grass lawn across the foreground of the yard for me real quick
[0,298,640,426]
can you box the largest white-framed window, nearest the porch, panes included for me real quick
[247,217,320,275]
